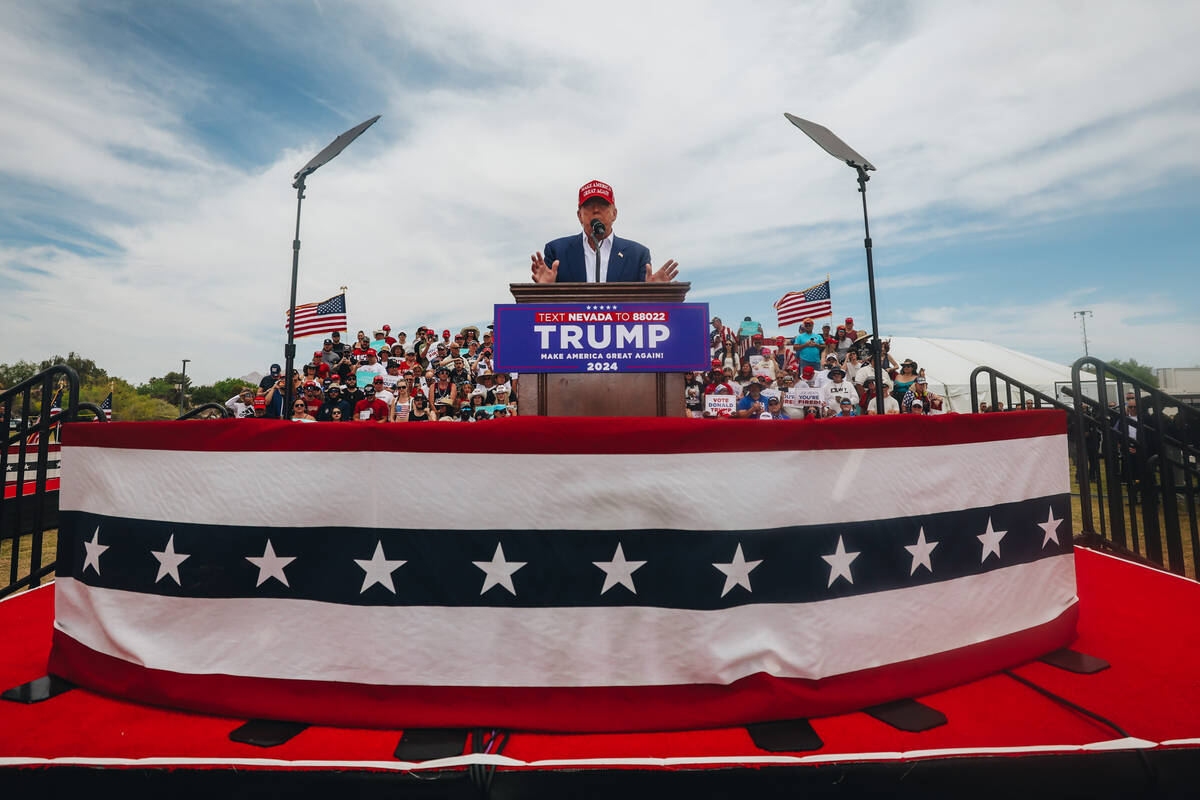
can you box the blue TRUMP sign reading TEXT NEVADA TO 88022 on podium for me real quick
[494,302,710,372]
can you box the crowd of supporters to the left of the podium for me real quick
[226,325,517,422]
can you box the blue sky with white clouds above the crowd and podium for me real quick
[0,0,1200,381]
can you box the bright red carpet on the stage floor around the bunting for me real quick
[0,549,1200,770]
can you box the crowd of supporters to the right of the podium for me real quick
[685,317,947,420]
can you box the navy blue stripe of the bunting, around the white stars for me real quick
[59,494,1072,609]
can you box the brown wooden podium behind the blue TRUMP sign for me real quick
[509,282,691,416]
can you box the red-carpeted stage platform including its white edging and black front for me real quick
[0,548,1200,798]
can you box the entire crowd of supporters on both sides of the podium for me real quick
[226,317,964,422]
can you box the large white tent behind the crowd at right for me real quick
[890,336,1070,414]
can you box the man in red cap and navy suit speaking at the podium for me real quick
[530,181,679,283]
